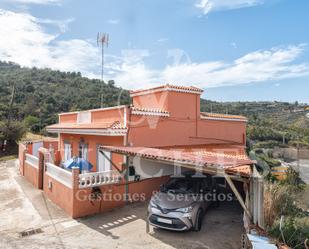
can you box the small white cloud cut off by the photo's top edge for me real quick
[195,0,264,15]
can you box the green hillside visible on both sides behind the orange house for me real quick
[0,62,309,154]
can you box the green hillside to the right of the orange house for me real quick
[201,100,309,147]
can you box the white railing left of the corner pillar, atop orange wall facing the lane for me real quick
[46,163,73,188]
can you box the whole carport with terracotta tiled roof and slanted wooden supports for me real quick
[100,145,263,226]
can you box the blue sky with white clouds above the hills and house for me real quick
[0,0,309,103]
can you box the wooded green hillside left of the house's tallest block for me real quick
[0,62,129,131]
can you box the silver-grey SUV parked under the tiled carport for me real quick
[148,172,217,231]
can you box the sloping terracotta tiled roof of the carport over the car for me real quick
[100,146,255,177]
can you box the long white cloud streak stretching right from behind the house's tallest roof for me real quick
[109,45,309,88]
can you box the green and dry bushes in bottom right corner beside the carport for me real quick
[264,169,309,249]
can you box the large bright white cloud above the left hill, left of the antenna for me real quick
[0,10,100,75]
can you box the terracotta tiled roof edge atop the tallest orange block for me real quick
[130,84,203,97]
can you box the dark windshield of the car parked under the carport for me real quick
[161,179,194,194]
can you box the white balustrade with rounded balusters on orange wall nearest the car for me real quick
[79,170,121,188]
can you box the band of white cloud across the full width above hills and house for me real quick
[0,10,309,92]
